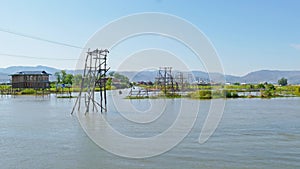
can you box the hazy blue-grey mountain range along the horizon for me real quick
[0,65,300,84]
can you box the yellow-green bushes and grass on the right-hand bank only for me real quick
[126,75,300,99]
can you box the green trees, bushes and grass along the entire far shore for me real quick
[0,74,300,99]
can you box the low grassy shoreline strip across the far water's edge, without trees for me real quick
[0,84,300,100]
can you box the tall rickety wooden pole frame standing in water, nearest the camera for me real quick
[71,49,109,114]
